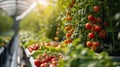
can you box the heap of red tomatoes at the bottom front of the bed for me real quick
[34,53,62,67]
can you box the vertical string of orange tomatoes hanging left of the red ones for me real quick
[64,0,76,44]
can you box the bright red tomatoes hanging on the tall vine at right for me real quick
[85,6,108,50]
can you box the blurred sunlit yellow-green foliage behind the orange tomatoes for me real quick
[20,0,63,40]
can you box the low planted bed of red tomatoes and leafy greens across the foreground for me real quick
[20,32,119,67]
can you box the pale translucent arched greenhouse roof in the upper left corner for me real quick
[0,0,35,16]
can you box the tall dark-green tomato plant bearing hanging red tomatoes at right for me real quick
[58,0,120,55]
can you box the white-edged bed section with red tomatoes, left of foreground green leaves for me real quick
[19,31,65,67]
